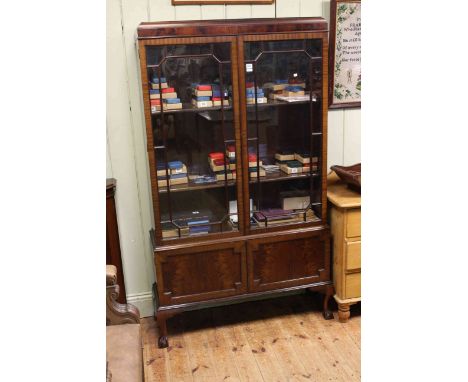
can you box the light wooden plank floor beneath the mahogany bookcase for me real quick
[142,294,361,382]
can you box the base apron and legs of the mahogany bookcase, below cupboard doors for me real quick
[153,281,334,348]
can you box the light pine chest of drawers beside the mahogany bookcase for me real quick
[327,172,361,322]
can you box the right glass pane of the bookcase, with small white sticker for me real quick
[245,40,323,229]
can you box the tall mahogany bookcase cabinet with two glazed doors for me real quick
[137,18,333,347]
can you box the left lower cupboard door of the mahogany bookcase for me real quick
[155,242,247,305]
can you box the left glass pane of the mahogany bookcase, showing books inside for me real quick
[146,43,239,240]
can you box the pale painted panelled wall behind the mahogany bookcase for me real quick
[106,0,361,316]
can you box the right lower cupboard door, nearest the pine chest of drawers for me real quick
[247,231,330,292]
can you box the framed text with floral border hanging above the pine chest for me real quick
[328,0,361,109]
